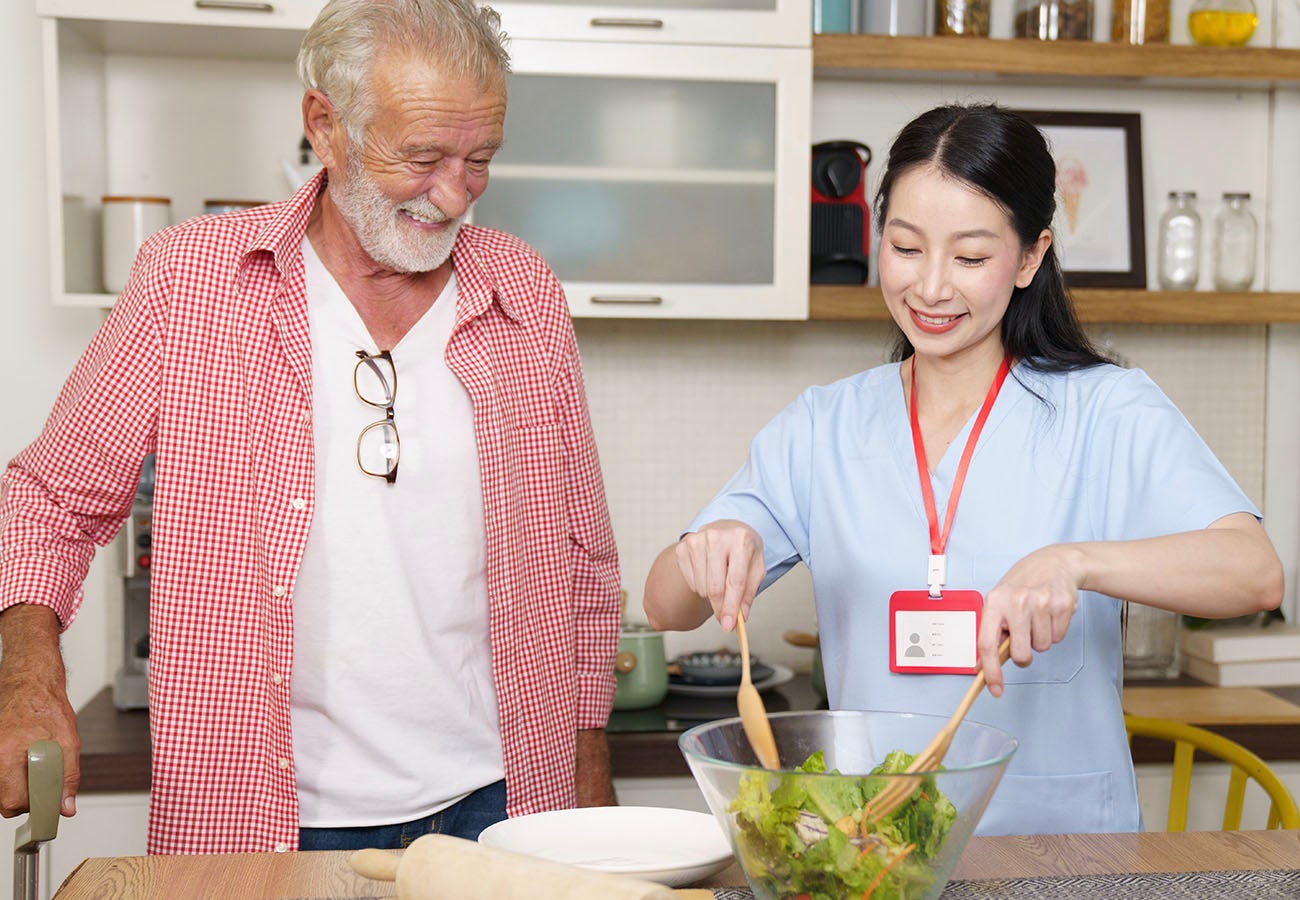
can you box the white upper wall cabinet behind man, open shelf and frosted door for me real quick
[38,0,813,319]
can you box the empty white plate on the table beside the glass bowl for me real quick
[478,806,732,887]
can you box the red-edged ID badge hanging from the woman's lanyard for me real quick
[889,590,984,675]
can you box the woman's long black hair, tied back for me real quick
[875,104,1110,372]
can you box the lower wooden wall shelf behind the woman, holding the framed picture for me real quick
[809,285,1300,325]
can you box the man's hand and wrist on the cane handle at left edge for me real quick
[0,603,81,818]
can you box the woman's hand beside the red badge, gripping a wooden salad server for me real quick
[978,544,1080,697]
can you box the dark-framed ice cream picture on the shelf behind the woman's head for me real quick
[1018,109,1147,287]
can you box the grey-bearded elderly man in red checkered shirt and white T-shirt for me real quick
[0,0,619,853]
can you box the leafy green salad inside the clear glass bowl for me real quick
[731,750,957,900]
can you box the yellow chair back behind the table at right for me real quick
[1125,715,1300,831]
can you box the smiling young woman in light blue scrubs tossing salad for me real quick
[645,105,1283,834]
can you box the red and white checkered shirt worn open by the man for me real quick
[0,171,619,853]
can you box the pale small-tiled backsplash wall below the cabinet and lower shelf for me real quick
[576,319,1266,670]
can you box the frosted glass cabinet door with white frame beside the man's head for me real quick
[473,42,810,319]
